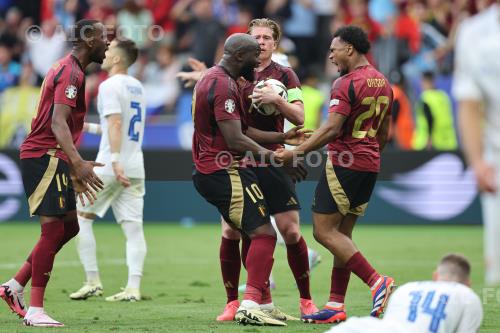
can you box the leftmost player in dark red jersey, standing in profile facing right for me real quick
[0,20,108,327]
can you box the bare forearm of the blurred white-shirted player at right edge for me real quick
[458,101,484,165]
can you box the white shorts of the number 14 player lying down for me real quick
[325,317,408,333]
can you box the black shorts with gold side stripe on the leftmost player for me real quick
[21,154,76,216]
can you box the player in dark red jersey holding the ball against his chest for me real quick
[217,18,318,321]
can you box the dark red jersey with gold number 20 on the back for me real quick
[328,65,392,172]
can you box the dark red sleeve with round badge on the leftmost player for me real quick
[54,65,85,108]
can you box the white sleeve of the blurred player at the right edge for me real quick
[452,21,483,101]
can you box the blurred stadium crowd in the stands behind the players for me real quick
[0,0,490,150]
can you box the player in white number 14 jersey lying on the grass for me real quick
[327,254,483,333]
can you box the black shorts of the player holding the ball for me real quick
[250,165,300,215]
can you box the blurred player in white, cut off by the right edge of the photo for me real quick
[453,1,500,285]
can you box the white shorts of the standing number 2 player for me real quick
[77,175,145,223]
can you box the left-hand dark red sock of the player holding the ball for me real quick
[219,237,241,303]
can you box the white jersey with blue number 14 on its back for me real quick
[383,281,483,333]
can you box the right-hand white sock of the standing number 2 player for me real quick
[121,221,147,289]
